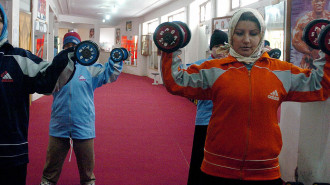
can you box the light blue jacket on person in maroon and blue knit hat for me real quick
[49,58,123,139]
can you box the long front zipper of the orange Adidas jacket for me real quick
[240,66,253,180]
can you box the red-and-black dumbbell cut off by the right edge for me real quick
[303,19,330,55]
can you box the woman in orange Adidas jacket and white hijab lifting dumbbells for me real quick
[162,9,330,185]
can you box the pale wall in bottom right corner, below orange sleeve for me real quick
[298,100,330,184]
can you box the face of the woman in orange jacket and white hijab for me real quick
[232,21,261,57]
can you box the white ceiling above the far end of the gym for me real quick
[53,0,174,26]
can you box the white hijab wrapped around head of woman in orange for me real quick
[228,8,266,64]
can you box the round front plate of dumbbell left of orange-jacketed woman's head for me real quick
[153,22,184,53]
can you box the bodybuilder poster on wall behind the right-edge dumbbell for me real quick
[290,0,330,69]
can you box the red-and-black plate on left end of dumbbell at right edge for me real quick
[303,19,330,49]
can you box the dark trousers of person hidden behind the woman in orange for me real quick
[187,125,207,185]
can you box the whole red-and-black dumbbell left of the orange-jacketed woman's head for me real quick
[153,21,191,53]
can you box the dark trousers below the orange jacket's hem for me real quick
[199,172,283,185]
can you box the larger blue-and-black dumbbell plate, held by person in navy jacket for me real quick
[74,40,100,66]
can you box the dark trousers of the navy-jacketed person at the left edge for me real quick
[0,164,27,185]
